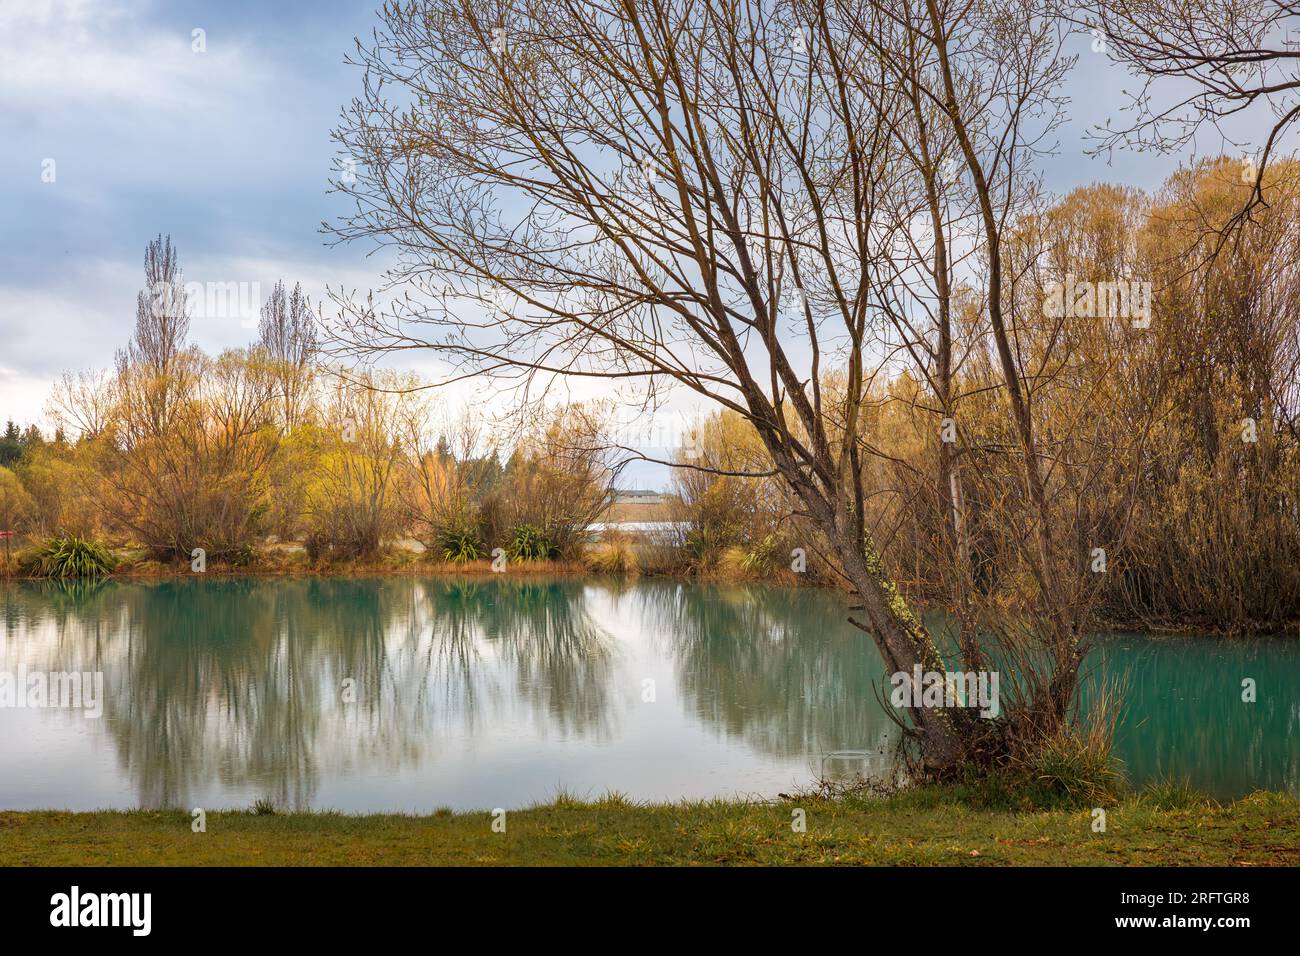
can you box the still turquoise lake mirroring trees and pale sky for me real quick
[0,576,1300,812]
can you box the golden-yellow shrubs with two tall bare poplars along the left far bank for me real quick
[0,238,624,575]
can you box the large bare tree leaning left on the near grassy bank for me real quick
[333,0,1076,770]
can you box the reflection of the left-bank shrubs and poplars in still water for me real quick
[0,578,612,808]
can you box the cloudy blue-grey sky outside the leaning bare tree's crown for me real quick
[0,0,1279,486]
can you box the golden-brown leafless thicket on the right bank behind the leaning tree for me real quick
[679,160,1300,642]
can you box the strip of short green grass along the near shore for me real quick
[0,788,1300,866]
